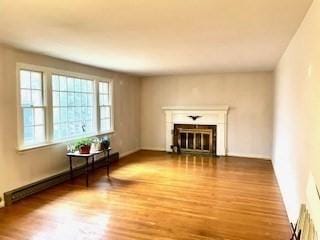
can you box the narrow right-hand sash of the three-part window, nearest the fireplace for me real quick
[99,82,111,131]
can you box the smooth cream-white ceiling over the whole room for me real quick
[0,0,312,75]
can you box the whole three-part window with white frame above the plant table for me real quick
[18,65,113,149]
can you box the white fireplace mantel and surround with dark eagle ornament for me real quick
[162,105,229,156]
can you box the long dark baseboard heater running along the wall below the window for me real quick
[4,152,119,206]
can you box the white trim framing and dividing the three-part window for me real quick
[16,63,114,151]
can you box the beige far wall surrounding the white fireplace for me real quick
[141,72,273,159]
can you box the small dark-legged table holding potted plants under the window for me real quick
[67,147,111,187]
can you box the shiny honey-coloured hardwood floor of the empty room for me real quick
[0,151,290,240]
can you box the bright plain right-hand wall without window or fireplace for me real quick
[273,0,320,221]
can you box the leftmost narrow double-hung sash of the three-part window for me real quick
[20,70,45,145]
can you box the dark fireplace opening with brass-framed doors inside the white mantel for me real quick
[173,124,217,155]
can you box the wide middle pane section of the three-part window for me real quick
[52,75,94,140]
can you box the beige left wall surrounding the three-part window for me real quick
[0,45,141,204]
